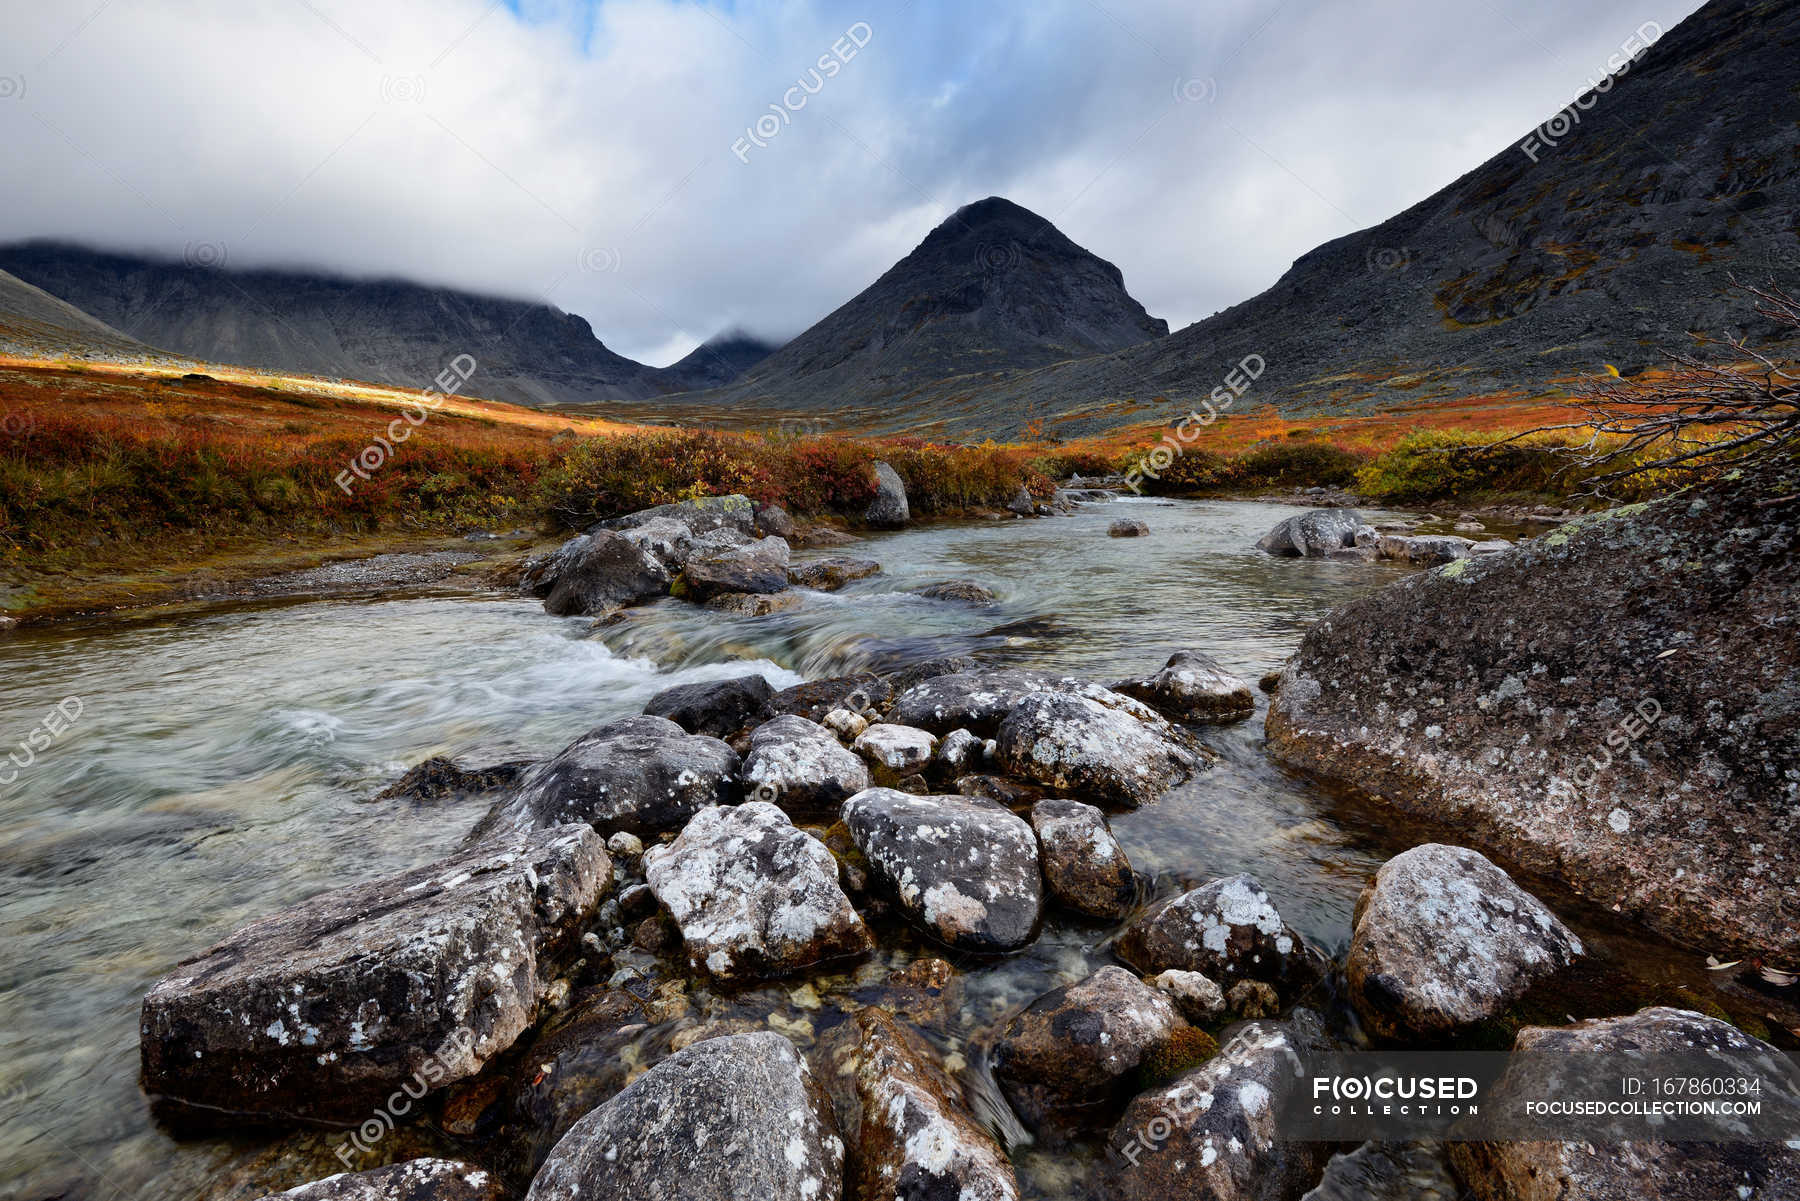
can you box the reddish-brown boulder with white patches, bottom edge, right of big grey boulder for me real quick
[839,1007,1019,1201]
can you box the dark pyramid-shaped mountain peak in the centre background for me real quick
[693,196,1168,411]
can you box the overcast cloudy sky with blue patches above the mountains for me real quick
[0,0,1697,366]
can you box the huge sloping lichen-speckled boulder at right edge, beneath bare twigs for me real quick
[1267,481,1800,962]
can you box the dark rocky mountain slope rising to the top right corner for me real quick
[923,0,1800,434]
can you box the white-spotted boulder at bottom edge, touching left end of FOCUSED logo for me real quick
[1107,1010,1332,1201]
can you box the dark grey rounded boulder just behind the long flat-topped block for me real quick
[488,717,738,834]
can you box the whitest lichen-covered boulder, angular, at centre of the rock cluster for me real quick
[644,803,875,983]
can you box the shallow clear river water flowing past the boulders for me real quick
[0,501,1432,1197]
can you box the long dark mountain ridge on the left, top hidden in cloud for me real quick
[0,241,759,405]
